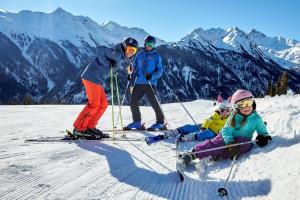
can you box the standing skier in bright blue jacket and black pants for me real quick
[124,36,165,130]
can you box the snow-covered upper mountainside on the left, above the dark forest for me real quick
[0,8,163,46]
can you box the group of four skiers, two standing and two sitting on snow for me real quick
[73,36,271,166]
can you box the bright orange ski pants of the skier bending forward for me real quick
[74,79,108,131]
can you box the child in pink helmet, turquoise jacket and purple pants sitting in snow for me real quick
[179,90,272,169]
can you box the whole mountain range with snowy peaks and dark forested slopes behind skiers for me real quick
[0,8,300,103]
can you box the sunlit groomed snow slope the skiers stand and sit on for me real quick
[0,95,300,200]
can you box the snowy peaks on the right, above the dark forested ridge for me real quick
[182,27,300,69]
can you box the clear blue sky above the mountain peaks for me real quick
[0,0,300,41]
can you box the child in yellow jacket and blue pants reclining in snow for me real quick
[145,95,232,144]
